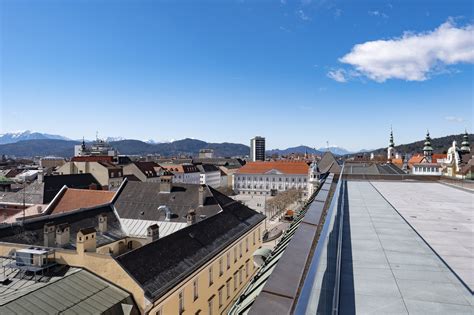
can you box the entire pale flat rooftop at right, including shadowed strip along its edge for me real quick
[307,180,474,314]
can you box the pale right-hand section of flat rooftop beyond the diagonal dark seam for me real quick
[372,181,474,291]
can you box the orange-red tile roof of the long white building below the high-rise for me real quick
[237,161,309,175]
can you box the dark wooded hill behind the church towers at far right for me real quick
[369,134,474,155]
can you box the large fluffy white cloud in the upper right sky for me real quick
[336,20,474,82]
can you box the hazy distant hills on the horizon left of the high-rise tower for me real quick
[0,139,249,157]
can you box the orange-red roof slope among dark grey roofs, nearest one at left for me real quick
[48,188,115,214]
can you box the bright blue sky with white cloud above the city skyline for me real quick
[0,0,474,150]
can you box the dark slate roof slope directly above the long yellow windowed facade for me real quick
[115,188,265,300]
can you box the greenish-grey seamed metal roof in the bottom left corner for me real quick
[0,258,136,314]
